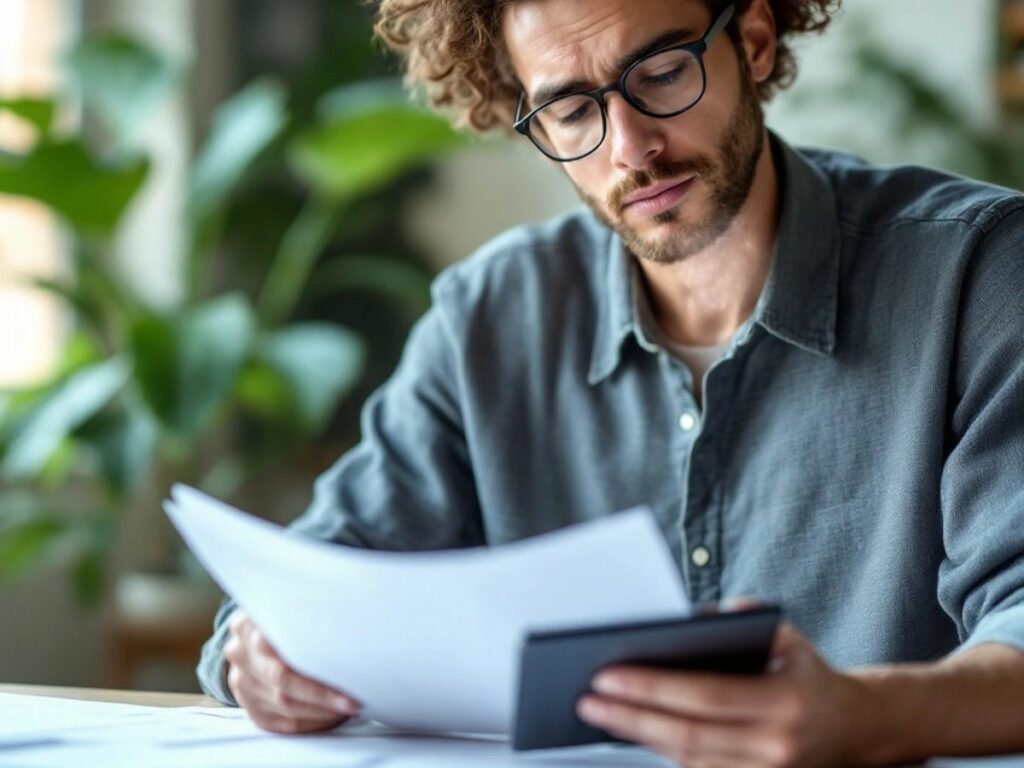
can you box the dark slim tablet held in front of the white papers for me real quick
[512,606,780,750]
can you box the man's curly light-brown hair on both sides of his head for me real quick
[369,0,842,133]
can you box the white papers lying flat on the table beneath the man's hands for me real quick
[0,694,670,768]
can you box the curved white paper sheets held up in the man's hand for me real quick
[165,485,689,734]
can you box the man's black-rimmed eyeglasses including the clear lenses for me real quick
[513,3,735,163]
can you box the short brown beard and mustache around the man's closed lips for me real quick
[577,61,764,264]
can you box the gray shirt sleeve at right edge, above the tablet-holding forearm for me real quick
[938,205,1024,663]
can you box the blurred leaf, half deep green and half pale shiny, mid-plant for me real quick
[131,294,256,439]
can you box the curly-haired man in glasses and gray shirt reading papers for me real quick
[201,0,1024,766]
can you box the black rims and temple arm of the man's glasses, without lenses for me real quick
[512,2,736,163]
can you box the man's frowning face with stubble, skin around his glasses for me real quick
[503,0,764,264]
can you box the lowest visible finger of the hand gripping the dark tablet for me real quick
[578,695,761,764]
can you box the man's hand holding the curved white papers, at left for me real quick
[224,611,359,733]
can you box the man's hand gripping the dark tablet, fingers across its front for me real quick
[579,625,872,768]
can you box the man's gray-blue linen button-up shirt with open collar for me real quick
[199,137,1024,702]
